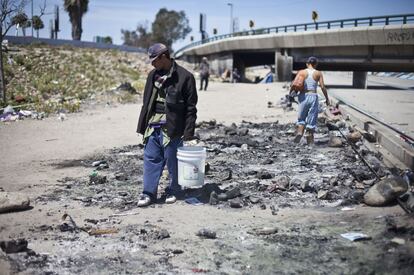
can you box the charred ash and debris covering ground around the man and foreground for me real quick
[2,117,414,274]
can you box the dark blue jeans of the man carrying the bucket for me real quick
[143,128,183,201]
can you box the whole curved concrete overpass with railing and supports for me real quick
[175,14,414,88]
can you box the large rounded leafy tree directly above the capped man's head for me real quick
[152,8,191,49]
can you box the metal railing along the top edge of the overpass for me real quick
[175,14,414,56]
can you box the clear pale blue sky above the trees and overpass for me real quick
[8,0,414,50]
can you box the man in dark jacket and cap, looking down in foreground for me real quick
[137,43,198,207]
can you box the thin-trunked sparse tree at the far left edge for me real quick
[0,0,26,104]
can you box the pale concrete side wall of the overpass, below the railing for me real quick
[183,24,414,55]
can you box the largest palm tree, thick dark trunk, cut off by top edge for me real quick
[64,0,89,40]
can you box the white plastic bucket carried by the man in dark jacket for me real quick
[177,146,207,188]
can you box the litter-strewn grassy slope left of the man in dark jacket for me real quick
[5,44,183,113]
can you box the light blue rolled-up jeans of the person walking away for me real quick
[297,92,319,130]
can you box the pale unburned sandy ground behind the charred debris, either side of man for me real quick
[0,82,296,194]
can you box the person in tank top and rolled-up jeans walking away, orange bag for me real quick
[291,56,329,145]
